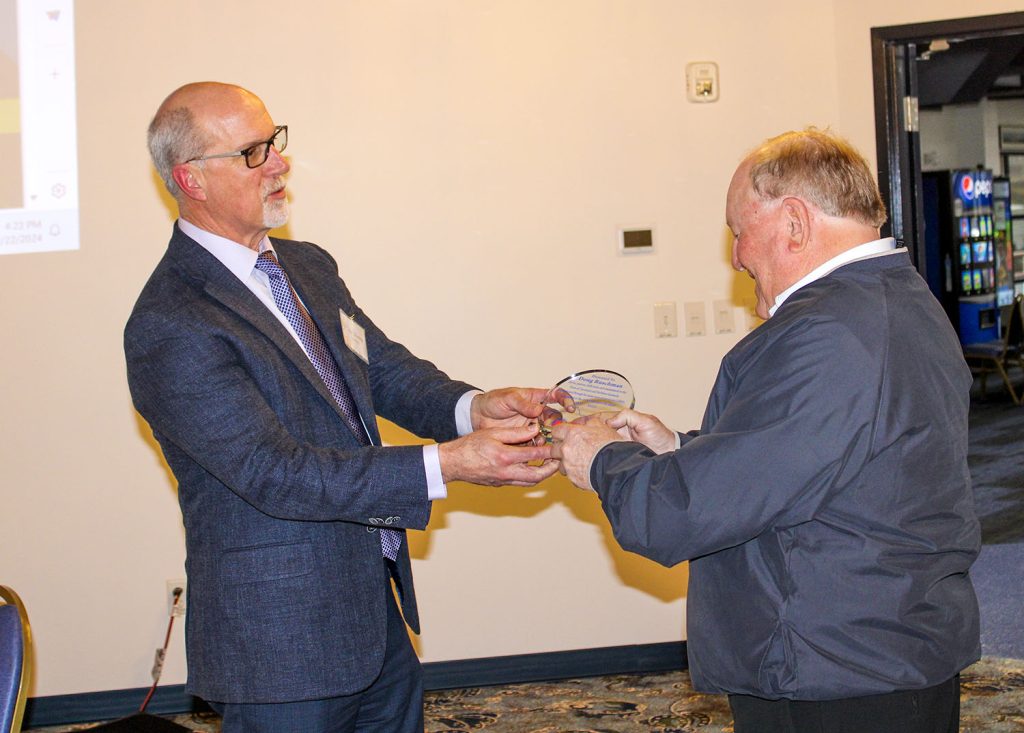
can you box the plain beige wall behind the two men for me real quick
[0,0,1013,695]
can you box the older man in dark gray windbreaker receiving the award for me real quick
[554,130,980,733]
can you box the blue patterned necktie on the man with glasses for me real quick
[256,250,401,560]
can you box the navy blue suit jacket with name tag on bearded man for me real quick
[125,227,472,702]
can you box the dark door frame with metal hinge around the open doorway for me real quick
[871,12,1024,274]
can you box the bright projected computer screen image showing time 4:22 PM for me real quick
[0,0,79,254]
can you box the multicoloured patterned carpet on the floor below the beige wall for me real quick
[22,658,1024,733]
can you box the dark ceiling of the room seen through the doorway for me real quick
[918,34,1024,107]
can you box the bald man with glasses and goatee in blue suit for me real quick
[125,82,556,733]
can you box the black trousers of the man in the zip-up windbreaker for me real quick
[729,675,959,733]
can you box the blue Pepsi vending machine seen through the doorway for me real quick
[922,169,999,344]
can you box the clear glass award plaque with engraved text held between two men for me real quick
[540,369,636,442]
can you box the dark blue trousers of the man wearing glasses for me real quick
[210,583,423,733]
